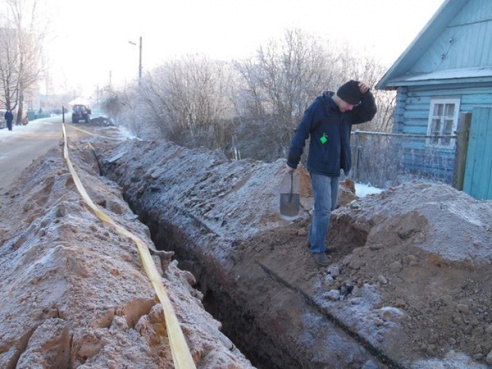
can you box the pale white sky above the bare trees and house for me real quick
[43,0,445,96]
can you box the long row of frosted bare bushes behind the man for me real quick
[103,29,395,161]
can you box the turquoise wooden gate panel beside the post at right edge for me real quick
[463,108,492,200]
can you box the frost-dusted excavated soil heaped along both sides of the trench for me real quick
[0,131,492,369]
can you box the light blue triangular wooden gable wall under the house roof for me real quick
[410,0,492,74]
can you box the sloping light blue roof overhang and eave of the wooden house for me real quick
[376,0,472,90]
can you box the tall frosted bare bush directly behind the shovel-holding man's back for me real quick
[235,30,331,160]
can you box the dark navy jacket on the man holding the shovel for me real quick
[287,91,377,177]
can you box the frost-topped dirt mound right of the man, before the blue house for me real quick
[328,183,492,367]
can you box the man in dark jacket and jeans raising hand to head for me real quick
[287,80,377,266]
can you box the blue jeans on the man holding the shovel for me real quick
[309,172,339,254]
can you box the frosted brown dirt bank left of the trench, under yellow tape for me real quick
[0,141,252,369]
